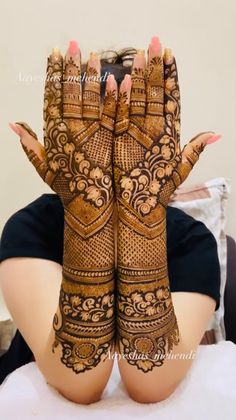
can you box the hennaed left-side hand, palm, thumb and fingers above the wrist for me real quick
[10,41,117,213]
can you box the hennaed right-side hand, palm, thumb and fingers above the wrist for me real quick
[114,37,219,218]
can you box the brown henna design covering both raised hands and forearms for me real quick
[13,38,219,373]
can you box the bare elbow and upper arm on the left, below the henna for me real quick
[0,257,113,404]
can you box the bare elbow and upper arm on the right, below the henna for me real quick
[119,292,215,403]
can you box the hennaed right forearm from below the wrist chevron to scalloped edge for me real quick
[118,212,178,371]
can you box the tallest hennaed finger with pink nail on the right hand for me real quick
[145,37,164,137]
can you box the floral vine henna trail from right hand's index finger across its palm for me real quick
[120,57,181,216]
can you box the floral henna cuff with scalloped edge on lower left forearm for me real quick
[53,289,114,373]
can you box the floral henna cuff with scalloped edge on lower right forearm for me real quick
[118,278,178,372]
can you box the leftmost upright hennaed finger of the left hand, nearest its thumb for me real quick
[44,48,63,124]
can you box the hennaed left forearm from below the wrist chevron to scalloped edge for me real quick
[53,208,114,371]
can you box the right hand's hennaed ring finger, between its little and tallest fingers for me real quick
[130,50,146,117]
